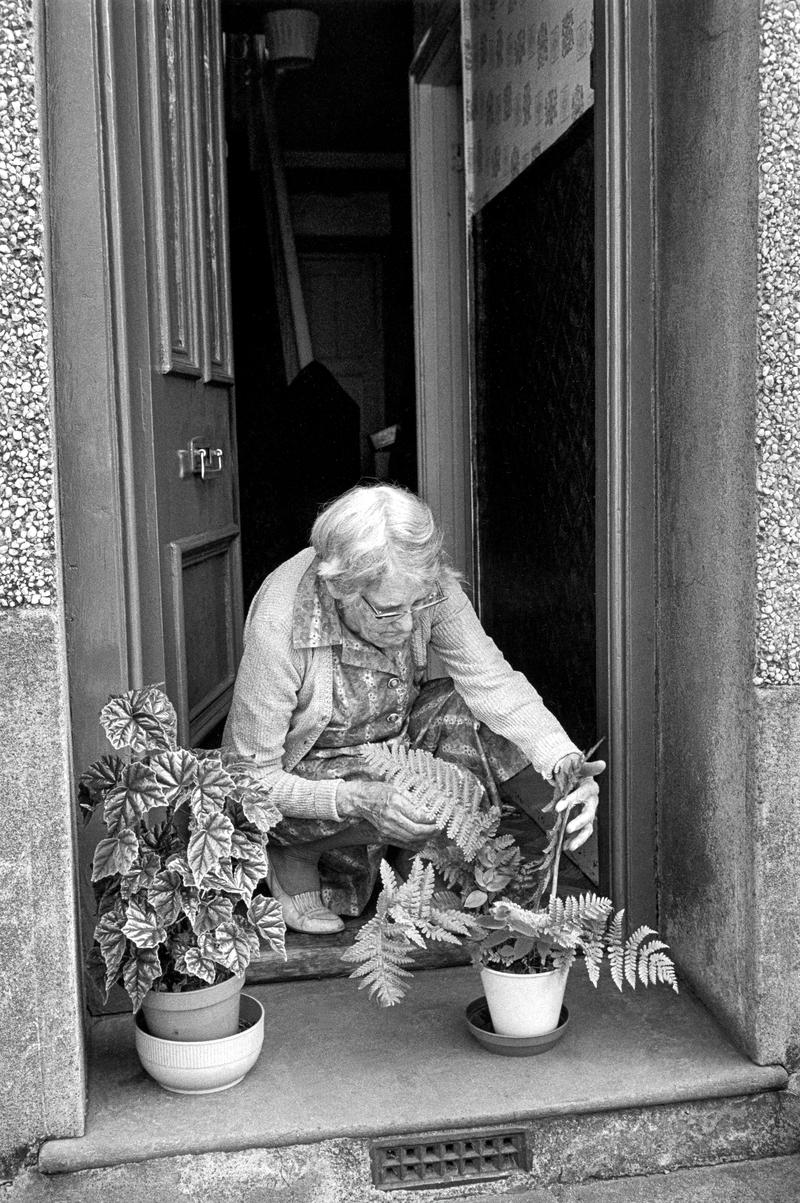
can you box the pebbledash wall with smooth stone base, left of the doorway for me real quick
[0,0,84,1163]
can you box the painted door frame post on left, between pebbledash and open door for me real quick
[36,0,165,779]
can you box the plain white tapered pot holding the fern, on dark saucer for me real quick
[480,967,569,1036]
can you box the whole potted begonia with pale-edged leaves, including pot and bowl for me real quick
[79,686,285,1091]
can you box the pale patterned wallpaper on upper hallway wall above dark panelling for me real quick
[462,0,594,212]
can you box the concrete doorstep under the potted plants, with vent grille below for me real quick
[10,966,800,1203]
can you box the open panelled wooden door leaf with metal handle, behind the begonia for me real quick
[130,0,242,743]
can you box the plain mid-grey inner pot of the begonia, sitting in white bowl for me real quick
[142,977,244,1041]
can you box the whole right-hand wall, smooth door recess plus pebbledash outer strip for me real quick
[654,0,800,1068]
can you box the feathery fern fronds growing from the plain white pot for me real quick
[343,745,677,1007]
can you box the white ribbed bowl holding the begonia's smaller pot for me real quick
[136,994,263,1095]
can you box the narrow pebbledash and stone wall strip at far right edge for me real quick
[752,0,800,1067]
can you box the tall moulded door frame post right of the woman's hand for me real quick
[594,0,658,924]
